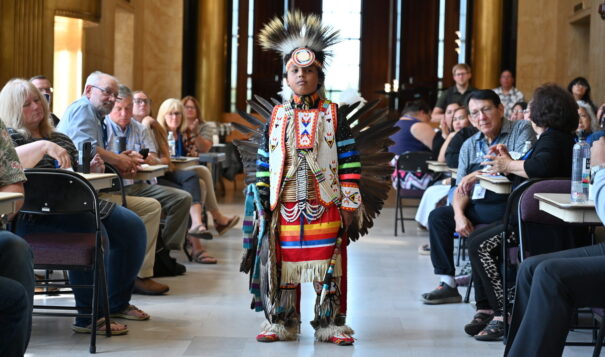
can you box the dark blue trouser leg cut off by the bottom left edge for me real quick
[0,231,34,357]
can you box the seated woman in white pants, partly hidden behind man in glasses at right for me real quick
[415,104,470,227]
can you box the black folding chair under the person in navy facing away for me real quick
[395,151,433,236]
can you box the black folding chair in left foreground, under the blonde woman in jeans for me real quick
[20,169,111,353]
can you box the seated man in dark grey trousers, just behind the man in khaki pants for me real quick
[104,85,191,250]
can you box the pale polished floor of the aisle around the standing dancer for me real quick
[27,186,592,357]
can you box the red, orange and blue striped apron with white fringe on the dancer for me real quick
[278,202,342,285]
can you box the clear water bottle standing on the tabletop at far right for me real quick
[571,130,590,202]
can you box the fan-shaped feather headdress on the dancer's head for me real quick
[259,10,340,68]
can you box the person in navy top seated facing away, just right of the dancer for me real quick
[389,100,435,190]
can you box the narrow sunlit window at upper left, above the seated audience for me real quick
[53,16,83,118]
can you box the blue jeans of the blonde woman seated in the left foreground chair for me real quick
[17,206,147,326]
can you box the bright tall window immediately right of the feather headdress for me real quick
[322,0,361,101]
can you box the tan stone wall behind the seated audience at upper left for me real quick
[0,0,183,117]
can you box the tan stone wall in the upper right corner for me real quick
[517,0,605,105]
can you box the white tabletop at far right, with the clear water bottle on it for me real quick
[534,193,601,223]
